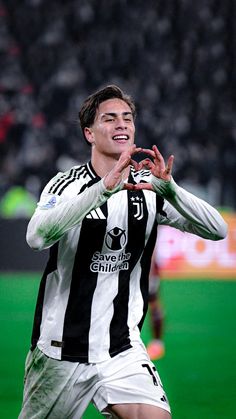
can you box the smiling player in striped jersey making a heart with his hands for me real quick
[20,85,227,419]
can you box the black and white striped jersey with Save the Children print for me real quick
[27,163,228,363]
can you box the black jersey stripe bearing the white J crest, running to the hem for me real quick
[109,189,148,357]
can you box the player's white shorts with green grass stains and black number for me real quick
[19,345,170,419]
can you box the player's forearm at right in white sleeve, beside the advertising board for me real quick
[152,176,227,240]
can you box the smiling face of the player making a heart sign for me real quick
[85,99,135,157]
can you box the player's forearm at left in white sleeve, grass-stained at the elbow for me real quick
[26,180,116,250]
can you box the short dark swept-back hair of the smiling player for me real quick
[79,84,136,145]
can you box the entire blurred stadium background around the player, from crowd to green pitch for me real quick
[0,0,236,419]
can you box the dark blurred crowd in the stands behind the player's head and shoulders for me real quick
[0,0,236,217]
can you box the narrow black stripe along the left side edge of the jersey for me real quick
[31,242,58,351]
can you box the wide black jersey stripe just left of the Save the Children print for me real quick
[62,181,107,363]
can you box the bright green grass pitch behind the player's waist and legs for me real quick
[0,274,236,419]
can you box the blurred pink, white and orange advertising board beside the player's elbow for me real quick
[155,213,236,279]
